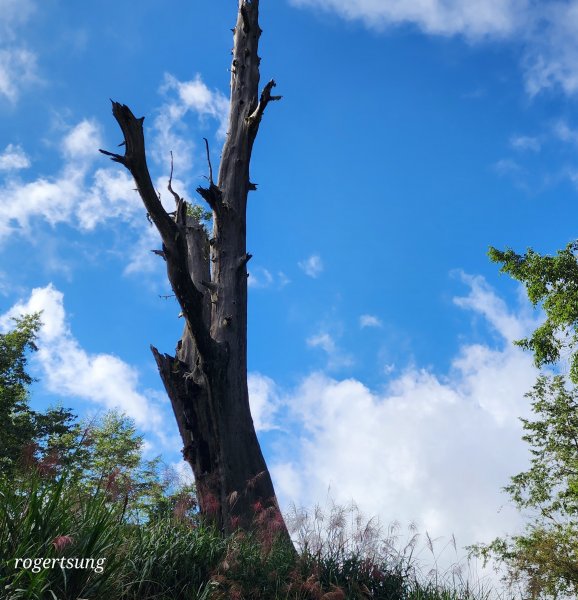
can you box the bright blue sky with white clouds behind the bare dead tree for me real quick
[0,0,578,580]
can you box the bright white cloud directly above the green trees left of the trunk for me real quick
[0,284,163,435]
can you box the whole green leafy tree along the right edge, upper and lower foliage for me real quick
[473,242,578,599]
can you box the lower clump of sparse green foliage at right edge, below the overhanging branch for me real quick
[473,376,578,598]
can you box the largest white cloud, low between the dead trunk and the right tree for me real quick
[272,276,536,572]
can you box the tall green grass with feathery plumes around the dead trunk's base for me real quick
[0,473,504,600]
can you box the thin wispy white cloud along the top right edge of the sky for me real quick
[291,0,578,96]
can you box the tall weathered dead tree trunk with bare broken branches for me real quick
[103,0,287,535]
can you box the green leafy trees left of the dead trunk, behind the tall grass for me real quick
[0,314,196,517]
